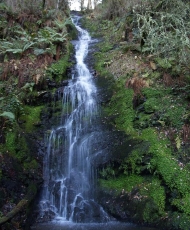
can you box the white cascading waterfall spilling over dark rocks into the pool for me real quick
[31,15,157,230]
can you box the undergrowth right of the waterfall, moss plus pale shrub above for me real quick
[88,1,190,227]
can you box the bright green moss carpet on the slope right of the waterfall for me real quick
[85,11,190,229]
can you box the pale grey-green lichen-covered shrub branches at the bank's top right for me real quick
[136,0,190,68]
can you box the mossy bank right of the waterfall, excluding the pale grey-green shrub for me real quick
[83,1,190,230]
